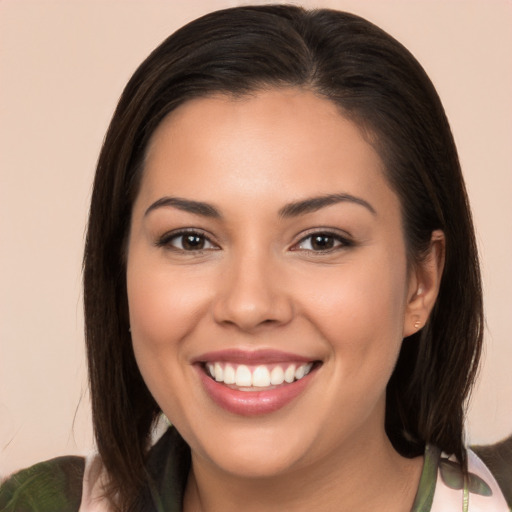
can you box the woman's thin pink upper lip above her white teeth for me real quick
[192,349,315,365]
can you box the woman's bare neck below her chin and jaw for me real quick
[184,422,423,512]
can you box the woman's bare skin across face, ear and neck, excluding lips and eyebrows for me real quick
[127,89,443,512]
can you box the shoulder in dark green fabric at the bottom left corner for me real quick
[0,456,85,512]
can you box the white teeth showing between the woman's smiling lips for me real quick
[203,361,320,392]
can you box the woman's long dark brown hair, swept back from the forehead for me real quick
[84,5,483,510]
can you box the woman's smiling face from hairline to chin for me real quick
[127,89,424,476]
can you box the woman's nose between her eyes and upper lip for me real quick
[213,249,293,332]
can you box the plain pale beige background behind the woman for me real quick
[0,0,512,475]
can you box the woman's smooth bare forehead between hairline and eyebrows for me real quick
[141,88,391,214]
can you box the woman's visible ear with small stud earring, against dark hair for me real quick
[403,229,446,338]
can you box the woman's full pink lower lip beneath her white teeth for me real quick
[198,367,315,416]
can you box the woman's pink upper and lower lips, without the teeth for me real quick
[194,350,315,416]
